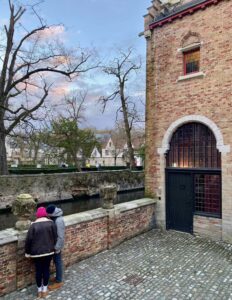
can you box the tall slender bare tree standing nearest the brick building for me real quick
[100,48,141,168]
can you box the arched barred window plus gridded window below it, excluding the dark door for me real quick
[166,123,221,217]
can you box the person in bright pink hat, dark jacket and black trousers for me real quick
[25,207,57,298]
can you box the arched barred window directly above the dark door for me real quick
[167,123,221,169]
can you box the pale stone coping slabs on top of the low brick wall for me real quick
[0,198,156,246]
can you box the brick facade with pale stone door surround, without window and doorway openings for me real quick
[144,0,232,241]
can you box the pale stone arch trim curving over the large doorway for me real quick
[157,115,230,155]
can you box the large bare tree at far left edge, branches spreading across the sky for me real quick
[0,0,96,175]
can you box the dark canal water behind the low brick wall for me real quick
[0,189,144,230]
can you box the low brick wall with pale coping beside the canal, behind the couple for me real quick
[0,198,156,296]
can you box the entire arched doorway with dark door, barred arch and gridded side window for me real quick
[166,122,221,233]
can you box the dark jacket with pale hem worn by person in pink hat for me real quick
[25,217,57,257]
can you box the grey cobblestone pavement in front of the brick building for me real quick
[2,230,232,300]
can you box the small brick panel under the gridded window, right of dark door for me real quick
[193,215,222,241]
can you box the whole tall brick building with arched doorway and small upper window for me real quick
[143,0,232,241]
